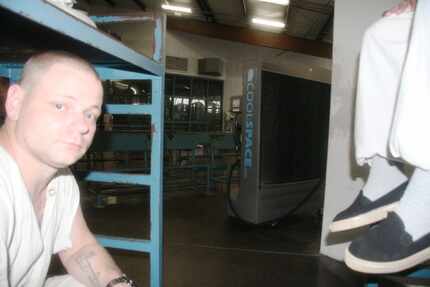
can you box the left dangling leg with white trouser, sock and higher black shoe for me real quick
[329,9,412,232]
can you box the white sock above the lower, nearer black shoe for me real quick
[395,168,430,241]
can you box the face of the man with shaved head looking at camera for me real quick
[16,64,103,169]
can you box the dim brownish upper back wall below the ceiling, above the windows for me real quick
[103,22,331,116]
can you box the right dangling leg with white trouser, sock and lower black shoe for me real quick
[345,1,430,273]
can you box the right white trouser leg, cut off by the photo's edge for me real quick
[390,0,430,170]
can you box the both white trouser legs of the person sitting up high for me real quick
[354,0,430,169]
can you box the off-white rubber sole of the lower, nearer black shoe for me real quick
[345,244,430,274]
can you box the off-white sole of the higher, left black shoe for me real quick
[329,202,398,232]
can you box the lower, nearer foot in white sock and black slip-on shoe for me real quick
[345,168,430,273]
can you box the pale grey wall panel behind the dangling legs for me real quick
[321,0,399,260]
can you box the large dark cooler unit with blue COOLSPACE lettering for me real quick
[228,65,330,224]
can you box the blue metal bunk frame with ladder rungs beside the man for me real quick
[0,0,165,287]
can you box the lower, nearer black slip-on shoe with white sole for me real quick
[345,212,430,274]
